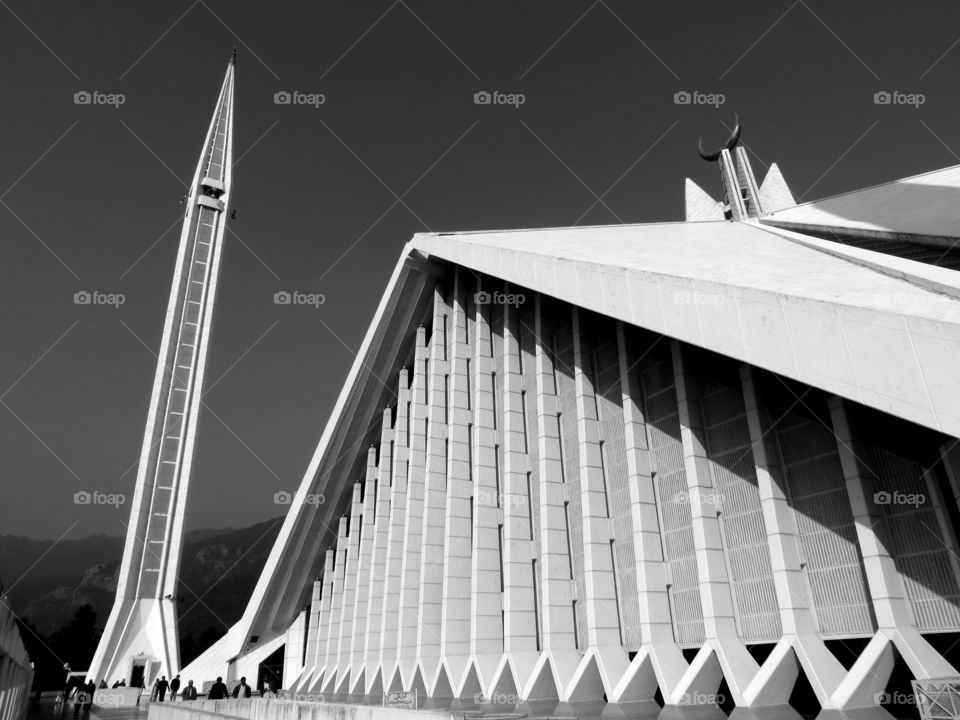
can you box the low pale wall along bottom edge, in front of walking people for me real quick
[148,698,452,720]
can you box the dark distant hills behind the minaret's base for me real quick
[0,517,283,662]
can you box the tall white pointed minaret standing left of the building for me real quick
[88,53,236,687]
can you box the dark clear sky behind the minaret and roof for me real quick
[0,0,960,538]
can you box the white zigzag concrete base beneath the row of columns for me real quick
[291,628,955,720]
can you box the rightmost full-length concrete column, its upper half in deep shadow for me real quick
[828,396,914,628]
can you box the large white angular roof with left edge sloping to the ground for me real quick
[176,212,960,666]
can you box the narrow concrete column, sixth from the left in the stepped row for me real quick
[363,408,394,676]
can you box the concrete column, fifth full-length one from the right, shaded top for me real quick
[573,307,621,647]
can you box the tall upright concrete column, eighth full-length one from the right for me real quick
[470,285,503,668]
